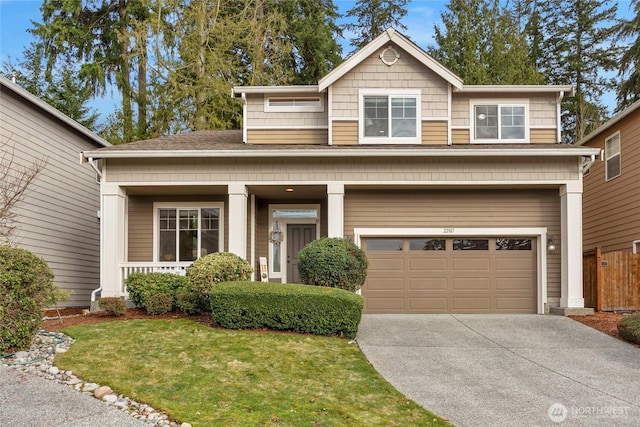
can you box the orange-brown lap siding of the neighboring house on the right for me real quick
[583,111,640,252]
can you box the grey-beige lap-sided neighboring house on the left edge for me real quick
[0,77,110,307]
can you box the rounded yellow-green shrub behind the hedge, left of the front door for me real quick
[187,252,253,307]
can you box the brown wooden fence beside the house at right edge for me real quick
[582,248,640,311]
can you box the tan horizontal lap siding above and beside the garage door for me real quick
[344,190,562,297]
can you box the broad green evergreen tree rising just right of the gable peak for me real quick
[429,0,544,85]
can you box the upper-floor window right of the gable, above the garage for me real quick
[471,103,527,143]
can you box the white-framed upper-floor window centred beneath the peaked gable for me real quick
[360,90,420,144]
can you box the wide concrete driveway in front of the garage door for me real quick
[357,314,640,426]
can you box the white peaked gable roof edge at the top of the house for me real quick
[318,28,462,91]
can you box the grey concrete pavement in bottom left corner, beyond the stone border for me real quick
[0,366,149,427]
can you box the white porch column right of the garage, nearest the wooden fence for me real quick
[560,182,584,308]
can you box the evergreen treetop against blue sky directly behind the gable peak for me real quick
[344,0,408,49]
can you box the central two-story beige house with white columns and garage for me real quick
[83,29,599,313]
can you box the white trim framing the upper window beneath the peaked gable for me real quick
[358,89,422,144]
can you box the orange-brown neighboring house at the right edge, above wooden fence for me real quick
[577,101,640,253]
